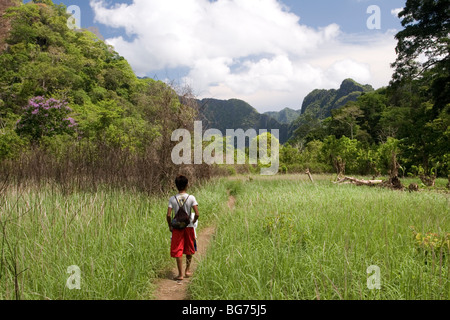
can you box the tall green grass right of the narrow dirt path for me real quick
[190,176,450,300]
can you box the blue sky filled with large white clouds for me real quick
[22,0,406,112]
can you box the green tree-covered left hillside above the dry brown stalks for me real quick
[0,1,196,162]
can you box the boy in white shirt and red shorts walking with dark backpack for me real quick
[167,176,199,281]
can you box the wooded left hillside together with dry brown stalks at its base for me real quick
[0,1,211,192]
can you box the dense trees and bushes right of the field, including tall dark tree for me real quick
[282,0,450,184]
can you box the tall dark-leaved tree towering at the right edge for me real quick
[386,0,450,175]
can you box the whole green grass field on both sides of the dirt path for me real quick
[0,176,450,300]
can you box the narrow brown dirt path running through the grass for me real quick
[155,196,236,301]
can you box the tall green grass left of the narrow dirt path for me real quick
[0,179,226,300]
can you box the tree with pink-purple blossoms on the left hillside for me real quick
[16,97,77,141]
